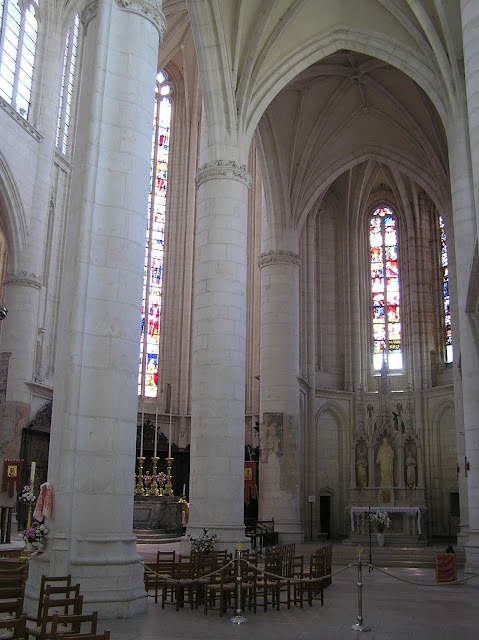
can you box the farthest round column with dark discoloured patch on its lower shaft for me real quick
[259,250,303,542]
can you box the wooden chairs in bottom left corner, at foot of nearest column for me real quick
[0,566,110,640]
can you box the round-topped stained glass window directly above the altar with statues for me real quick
[369,207,403,371]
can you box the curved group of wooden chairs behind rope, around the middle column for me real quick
[145,543,332,615]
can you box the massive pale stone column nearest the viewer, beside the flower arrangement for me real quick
[27,0,165,618]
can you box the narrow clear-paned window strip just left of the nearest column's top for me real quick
[55,15,80,154]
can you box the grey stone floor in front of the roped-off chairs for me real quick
[106,547,479,640]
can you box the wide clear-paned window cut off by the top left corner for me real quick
[0,0,40,118]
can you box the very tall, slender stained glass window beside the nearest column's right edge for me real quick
[138,71,171,398]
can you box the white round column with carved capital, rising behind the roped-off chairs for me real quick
[187,160,251,549]
